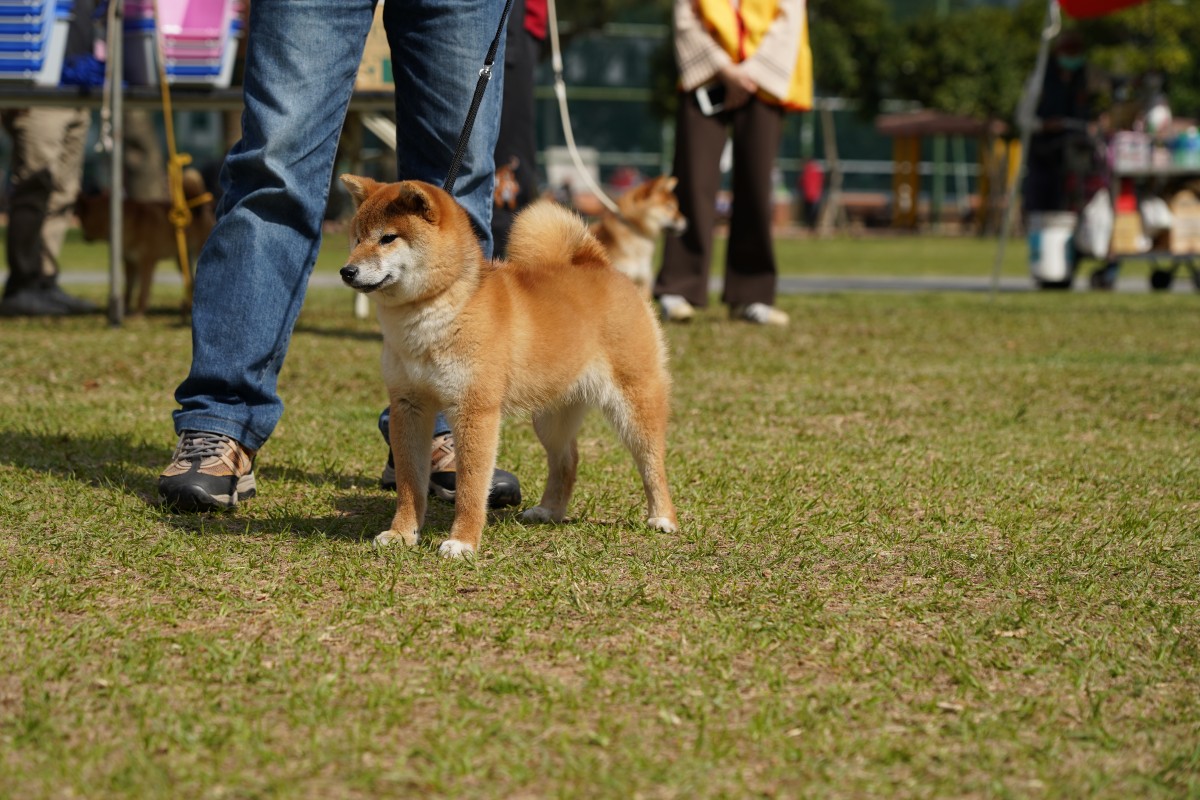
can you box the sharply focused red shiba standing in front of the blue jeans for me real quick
[341,175,678,558]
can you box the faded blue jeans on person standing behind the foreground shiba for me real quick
[174,0,504,450]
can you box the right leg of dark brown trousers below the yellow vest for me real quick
[721,100,784,308]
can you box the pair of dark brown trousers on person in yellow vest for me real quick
[654,94,784,307]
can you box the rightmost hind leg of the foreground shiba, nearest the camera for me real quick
[604,377,679,534]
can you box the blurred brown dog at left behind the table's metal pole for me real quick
[76,168,216,315]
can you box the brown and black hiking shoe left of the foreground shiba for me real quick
[158,431,256,511]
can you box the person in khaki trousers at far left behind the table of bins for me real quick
[0,0,98,317]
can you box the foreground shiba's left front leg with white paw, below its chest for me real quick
[374,398,437,546]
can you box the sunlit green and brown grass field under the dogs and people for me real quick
[0,240,1200,799]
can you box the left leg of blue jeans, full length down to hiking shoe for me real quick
[174,0,374,449]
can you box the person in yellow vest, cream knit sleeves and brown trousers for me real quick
[654,0,812,325]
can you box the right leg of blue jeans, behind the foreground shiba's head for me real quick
[383,0,505,258]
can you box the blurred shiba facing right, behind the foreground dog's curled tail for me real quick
[592,175,688,299]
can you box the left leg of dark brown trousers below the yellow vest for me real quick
[654,94,727,308]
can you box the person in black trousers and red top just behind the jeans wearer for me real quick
[492,0,546,258]
